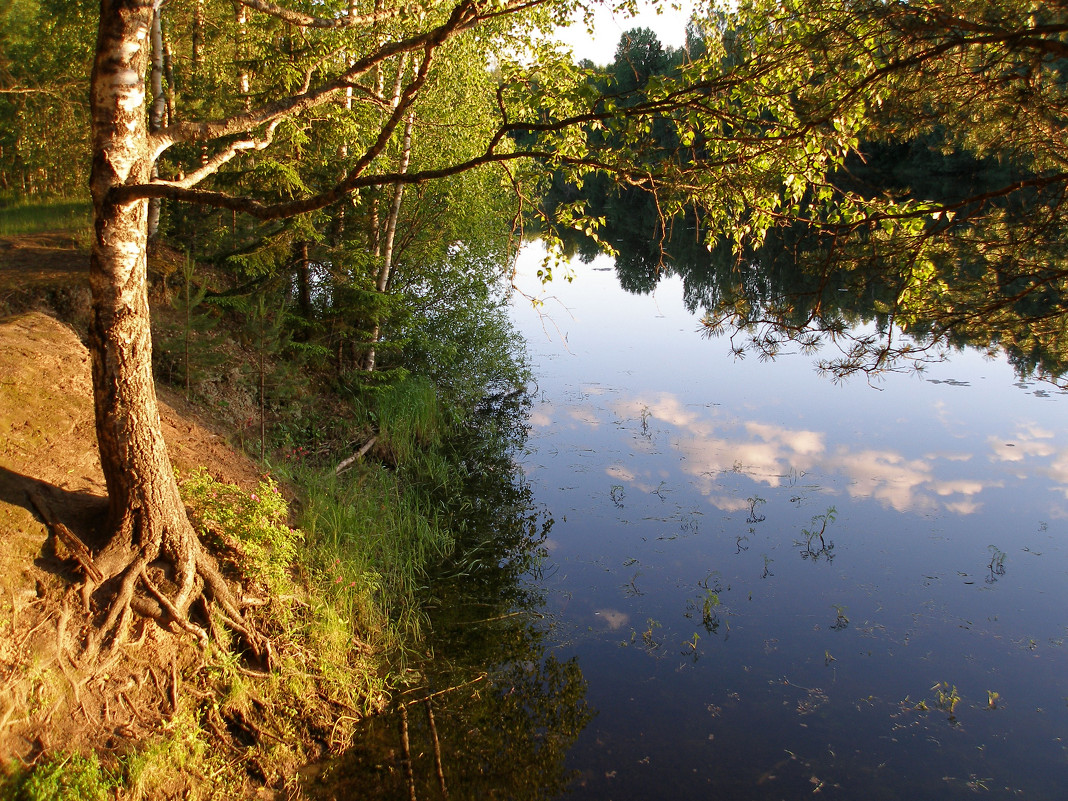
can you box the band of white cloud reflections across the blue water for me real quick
[532,388,1068,515]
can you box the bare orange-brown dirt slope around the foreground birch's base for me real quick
[0,301,260,760]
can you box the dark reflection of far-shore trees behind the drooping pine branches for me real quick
[548,151,1068,380]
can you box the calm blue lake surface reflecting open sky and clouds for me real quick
[514,247,1068,800]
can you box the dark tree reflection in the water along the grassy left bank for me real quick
[305,396,592,799]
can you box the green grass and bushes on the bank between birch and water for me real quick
[0,187,537,801]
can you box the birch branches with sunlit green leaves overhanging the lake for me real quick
[101,0,1066,263]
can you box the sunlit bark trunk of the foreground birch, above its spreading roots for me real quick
[89,0,192,606]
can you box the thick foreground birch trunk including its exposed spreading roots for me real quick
[89,0,266,656]
